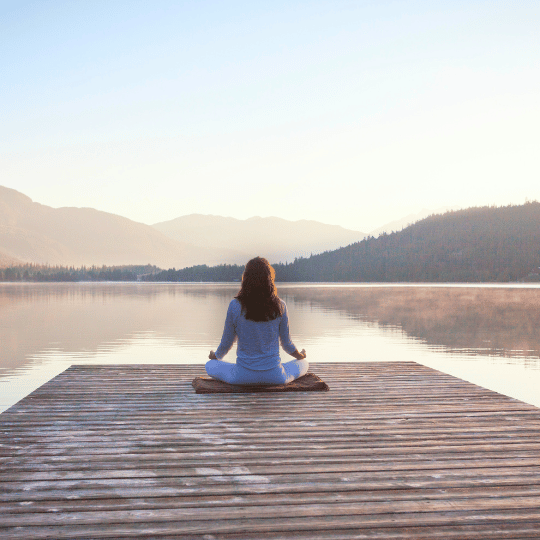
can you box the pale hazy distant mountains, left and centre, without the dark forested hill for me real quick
[0,186,365,268]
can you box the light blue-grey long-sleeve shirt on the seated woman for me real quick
[216,298,296,371]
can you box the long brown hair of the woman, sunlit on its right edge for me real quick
[235,257,282,322]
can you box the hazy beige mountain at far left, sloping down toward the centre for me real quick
[0,186,242,268]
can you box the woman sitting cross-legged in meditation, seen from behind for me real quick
[206,257,308,384]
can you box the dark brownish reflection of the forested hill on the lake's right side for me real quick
[282,286,540,358]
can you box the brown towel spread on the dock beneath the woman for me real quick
[191,373,329,394]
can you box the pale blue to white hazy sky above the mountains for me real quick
[0,0,540,232]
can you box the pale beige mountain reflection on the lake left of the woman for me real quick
[0,284,237,369]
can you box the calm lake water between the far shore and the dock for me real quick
[0,283,540,411]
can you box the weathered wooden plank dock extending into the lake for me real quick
[0,362,540,540]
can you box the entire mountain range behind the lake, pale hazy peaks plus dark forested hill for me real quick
[0,186,540,282]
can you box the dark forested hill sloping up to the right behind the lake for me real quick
[146,202,540,282]
